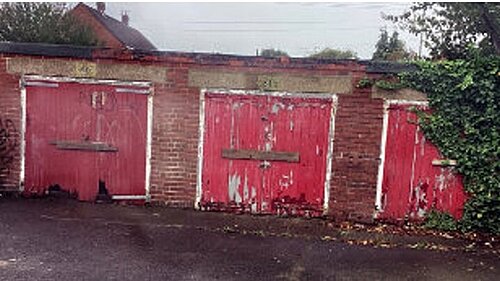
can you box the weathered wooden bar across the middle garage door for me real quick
[222,148,300,163]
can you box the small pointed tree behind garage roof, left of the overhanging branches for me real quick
[372,29,411,61]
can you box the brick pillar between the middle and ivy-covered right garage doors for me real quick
[329,89,383,221]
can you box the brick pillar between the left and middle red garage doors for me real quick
[151,66,199,208]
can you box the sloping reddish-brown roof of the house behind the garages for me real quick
[79,3,156,50]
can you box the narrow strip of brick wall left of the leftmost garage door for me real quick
[0,57,21,191]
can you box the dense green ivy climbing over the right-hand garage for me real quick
[400,54,500,233]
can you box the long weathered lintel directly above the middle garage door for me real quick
[188,69,353,94]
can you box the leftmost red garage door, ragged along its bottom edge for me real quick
[25,77,149,200]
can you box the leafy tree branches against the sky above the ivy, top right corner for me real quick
[385,2,500,59]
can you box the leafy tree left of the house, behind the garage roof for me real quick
[0,2,98,46]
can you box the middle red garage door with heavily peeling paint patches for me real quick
[200,93,332,216]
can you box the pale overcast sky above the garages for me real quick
[95,2,419,59]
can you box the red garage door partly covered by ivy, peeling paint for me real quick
[379,104,465,220]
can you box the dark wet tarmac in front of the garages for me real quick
[0,198,500,281]
